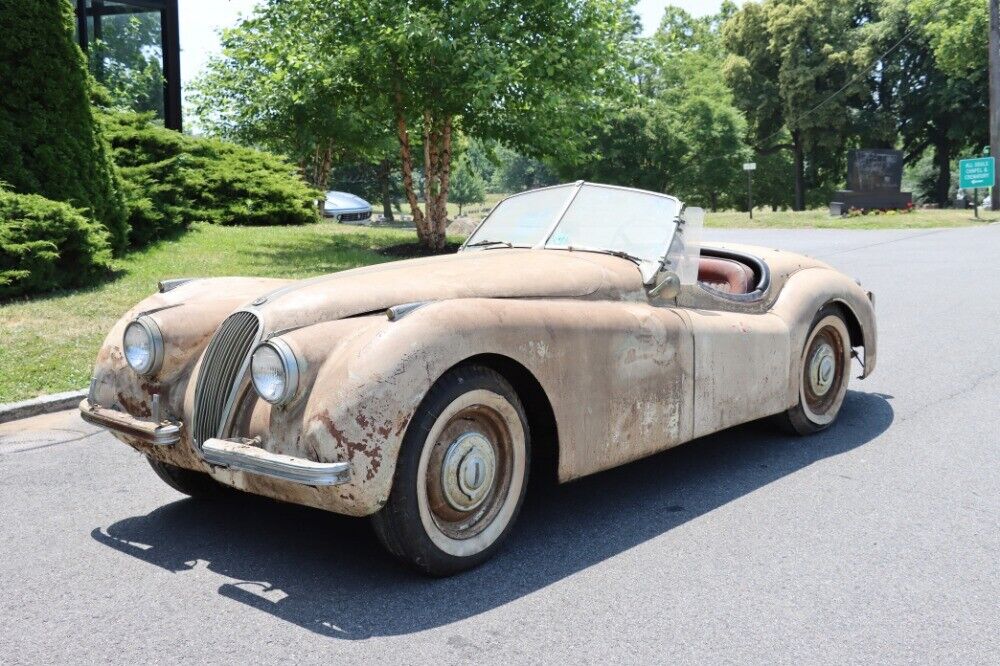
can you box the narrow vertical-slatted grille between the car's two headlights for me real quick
[193,312,260,446]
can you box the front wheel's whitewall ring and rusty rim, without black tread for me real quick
[417,390,525,556]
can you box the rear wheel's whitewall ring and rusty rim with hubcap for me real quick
[801,317,850,425]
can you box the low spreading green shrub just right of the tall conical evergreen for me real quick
[103,112,320,246]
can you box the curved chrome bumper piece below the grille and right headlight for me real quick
[201,439,351,486]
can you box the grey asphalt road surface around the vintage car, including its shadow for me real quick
[0,225,1000,664]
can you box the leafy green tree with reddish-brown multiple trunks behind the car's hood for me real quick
[340,0,631,248]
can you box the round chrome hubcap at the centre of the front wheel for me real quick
[441,432,497,511]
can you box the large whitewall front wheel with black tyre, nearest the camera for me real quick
[372,366,530,576]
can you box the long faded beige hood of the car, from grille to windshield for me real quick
[252,248,642,331]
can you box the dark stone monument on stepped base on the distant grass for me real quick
[830,148,913,215]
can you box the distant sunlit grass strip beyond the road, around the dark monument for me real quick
[705,209,1000,229]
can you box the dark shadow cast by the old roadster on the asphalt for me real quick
[92,391,893,639]
